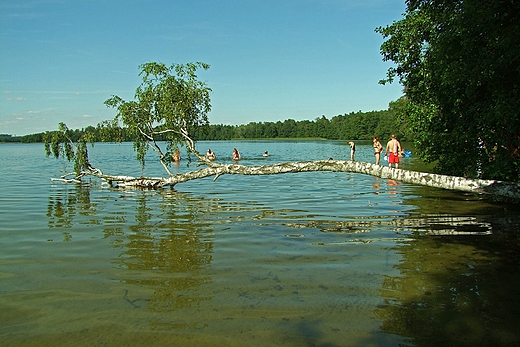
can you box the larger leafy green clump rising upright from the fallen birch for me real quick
[101,62,211,176]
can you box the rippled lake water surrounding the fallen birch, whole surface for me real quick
[0,141,520,346]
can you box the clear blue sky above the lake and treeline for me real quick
[0,0,405,135]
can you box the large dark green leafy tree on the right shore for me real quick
[376,0,520,181]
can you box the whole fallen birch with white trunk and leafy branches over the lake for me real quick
[44,63,520,201]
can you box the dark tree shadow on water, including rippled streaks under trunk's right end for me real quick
[375,187,520,347]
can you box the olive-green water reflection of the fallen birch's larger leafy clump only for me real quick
[120,191,213,312]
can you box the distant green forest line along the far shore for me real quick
[0,98,413,143]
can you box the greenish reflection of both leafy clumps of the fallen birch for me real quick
[47,186,216,320]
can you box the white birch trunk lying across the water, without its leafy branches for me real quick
[53,160,520,201]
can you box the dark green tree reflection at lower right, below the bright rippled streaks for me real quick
[376,234,520,347]
